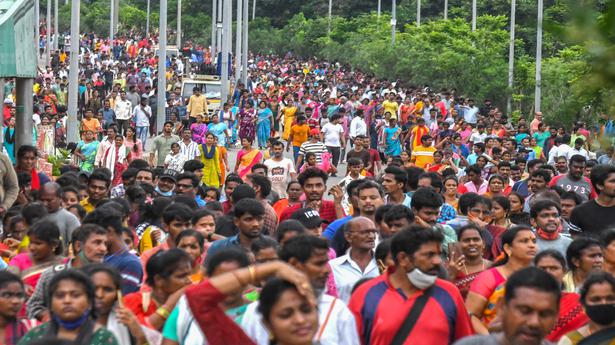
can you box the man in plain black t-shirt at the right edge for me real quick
[570,165,615,238]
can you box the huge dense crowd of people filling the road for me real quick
[0,30,615,345]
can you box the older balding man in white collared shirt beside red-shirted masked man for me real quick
[329,217,380,303]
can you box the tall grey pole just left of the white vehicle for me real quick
[156,0,167,132]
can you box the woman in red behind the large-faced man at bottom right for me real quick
[534,249,589,342]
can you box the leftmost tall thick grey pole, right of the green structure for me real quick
[66,0,81,143]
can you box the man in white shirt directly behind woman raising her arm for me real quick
[240,235,360,345]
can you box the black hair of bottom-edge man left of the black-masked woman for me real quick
[504,267,561,305]
